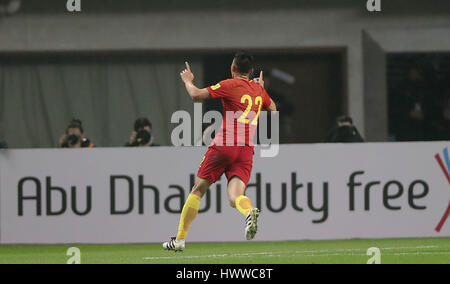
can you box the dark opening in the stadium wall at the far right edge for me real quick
[388,54,450,141]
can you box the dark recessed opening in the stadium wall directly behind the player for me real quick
[204,49,346,143]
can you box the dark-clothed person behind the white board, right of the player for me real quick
[324,116,364,143]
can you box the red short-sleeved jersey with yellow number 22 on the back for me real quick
[207,79,271,146]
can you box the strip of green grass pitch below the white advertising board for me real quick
[0,238,450,264]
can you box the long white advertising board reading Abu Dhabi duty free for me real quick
[0,142,450,244]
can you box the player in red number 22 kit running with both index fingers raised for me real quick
[163,52,276,251]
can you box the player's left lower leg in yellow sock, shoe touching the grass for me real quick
[163,177,211,251]
